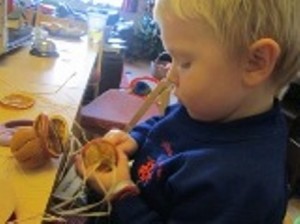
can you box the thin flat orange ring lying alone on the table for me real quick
[0,93,35,110]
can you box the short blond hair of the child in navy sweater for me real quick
[154,0,300,87]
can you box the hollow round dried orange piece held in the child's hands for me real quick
[81,138,118,171]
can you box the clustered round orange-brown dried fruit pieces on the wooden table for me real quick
[10,113,68,169]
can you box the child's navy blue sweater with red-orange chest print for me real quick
[112,102,287,224]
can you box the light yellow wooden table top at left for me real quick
[0,36,98,224]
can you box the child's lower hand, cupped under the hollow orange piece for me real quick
[74,151,138,200]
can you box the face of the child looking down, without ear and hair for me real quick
[160,18,248,121]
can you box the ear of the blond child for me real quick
[243,38,281,86]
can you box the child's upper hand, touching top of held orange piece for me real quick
[102,129,138,156]
